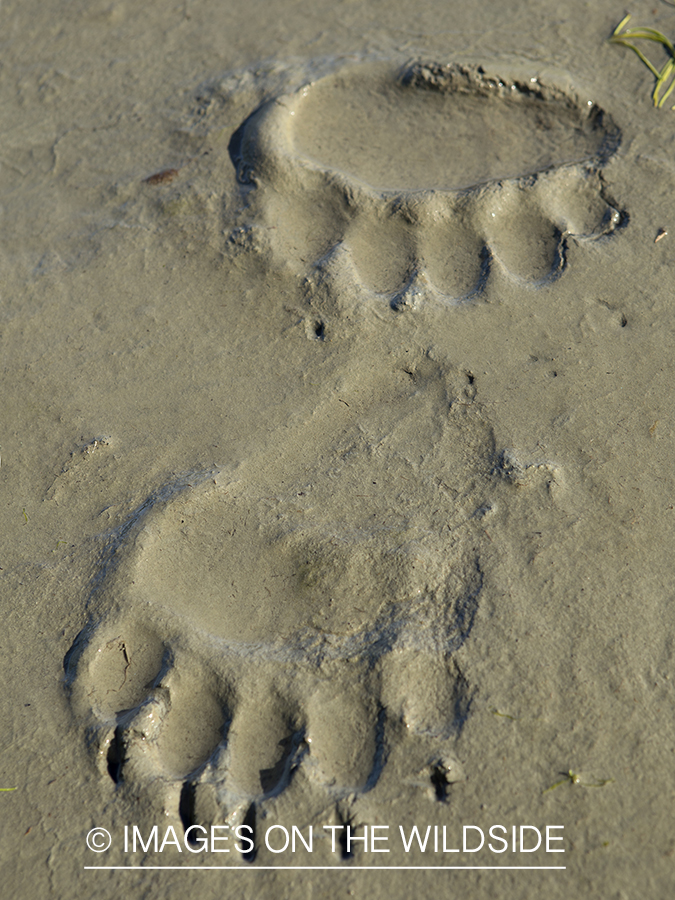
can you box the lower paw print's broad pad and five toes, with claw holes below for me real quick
[66,396,490,844]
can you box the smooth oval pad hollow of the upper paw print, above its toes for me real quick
[293,67,607,190]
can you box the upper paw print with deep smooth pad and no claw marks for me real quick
[230,63,627,309]
